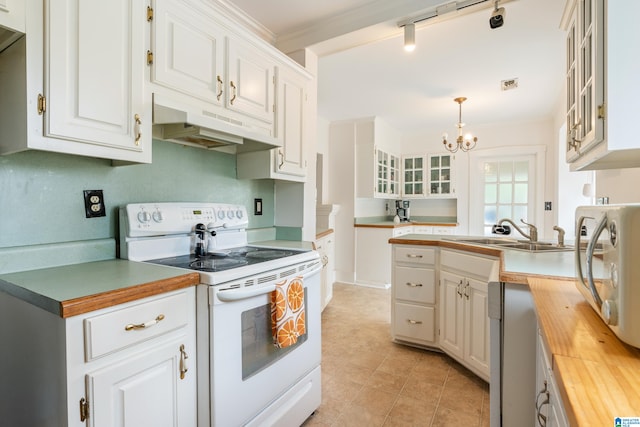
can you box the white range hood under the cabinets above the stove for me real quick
[153,94,282,153]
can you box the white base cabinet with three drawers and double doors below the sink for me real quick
[391,245,498,381]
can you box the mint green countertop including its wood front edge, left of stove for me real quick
[0,259,200,318]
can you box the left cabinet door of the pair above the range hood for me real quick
[151,1,228,106]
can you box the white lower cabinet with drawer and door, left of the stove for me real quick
[0,288,197,427]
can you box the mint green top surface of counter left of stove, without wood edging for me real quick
[0,259,195,317]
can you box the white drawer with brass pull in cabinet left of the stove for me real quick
[84,292,190,362]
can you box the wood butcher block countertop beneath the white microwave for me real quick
[529,278,640,426]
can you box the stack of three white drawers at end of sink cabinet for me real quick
[391,245,438,347]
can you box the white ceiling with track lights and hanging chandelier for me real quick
[226,0,565,133]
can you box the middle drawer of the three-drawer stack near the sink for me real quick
[393,266,436,304]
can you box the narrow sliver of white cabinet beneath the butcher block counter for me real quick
[534,331,569,427]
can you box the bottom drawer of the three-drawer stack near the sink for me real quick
[393,303,436,342]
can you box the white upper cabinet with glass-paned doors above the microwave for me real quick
[563,0,640,170]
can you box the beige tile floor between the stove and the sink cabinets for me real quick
[304,283,489,427]
